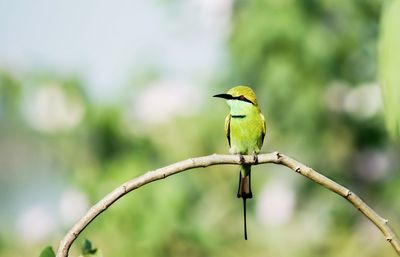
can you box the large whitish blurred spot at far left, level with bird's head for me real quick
[25,84,84,132]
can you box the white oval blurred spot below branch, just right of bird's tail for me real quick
[257,178,296,227]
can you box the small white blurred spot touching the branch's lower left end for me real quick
[59,188,89,226]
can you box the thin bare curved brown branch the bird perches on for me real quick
[57,152,400,257]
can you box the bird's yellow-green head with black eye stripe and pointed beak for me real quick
[214,86,258,114]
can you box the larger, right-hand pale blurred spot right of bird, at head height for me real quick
[343,84,382,119]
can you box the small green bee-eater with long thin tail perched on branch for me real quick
[214,86,266,240]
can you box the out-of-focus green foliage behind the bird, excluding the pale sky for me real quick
[0,0,400,257]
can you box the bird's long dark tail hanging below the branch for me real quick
[237,165,253,240]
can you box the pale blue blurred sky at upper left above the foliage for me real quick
[0,0,231,99]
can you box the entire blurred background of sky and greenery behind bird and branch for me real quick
[0,0,400,257]
